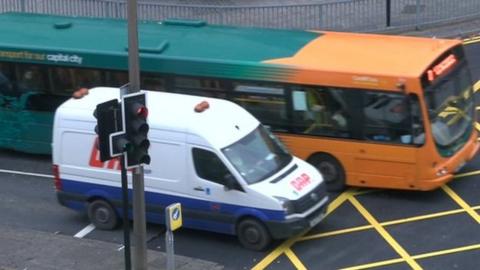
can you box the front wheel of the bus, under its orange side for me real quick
[308,154,345,191]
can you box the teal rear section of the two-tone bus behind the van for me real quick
[0,13,318,154]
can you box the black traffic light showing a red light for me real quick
[122,93,150,168]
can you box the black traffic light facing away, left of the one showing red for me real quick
[93,99,122,162]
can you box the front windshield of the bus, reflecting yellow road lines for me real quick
[426,64,474,156]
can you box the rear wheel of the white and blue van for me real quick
[88,199,118,230]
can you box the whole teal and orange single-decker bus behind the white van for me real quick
[0,13,479,190]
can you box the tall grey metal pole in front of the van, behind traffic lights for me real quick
[127,0,147,270]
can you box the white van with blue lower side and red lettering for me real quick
[53,87,328,250]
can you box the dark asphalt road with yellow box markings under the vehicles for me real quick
[0,39,480,269]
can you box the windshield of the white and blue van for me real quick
[222,125,292,184]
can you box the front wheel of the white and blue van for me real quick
[237,219,272,251]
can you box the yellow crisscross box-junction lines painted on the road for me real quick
[252,174,480,270]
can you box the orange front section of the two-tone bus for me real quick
[269,33,479,190]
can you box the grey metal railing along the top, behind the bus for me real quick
[0,0,480,32]
